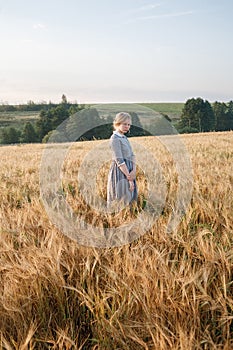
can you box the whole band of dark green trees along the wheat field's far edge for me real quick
[0,94,233,144]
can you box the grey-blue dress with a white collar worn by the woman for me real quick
[107,131,137,207]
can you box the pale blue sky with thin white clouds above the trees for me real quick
[0,0,233,104]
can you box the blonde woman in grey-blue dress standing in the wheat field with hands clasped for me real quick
[107,112,137,211]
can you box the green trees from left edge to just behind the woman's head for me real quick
[1,95,147,144]
